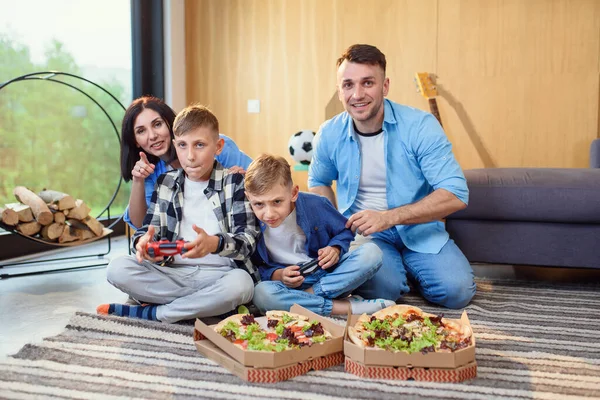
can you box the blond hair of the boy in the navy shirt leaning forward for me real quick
[244,154,293,195]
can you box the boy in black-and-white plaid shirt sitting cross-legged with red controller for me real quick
[97,105,260,323]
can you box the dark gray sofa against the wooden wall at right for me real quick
[446,139,600,268]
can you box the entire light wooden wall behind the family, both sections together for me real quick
[186,0,600,185]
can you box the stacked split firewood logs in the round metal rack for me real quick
[0,186,104,244]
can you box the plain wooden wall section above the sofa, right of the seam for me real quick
[436,0,600,168]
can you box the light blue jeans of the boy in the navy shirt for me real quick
[253,243,382,315]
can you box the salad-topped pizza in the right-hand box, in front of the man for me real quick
[348,305,473,354]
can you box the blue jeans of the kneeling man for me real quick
[354,228,476,308]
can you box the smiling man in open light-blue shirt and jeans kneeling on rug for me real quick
[308,44,475,308]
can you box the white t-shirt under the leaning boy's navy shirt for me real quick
[263,208,311,266]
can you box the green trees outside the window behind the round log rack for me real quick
[0,35,129,216]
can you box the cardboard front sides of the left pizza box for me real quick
[195,339,344,383]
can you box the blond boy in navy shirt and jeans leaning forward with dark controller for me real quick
[244,154,395,315]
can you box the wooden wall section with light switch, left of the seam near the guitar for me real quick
[185,0,436,189]
